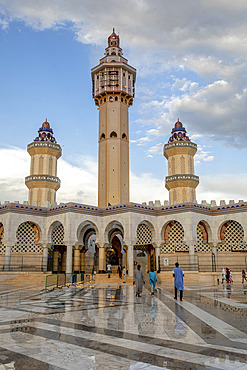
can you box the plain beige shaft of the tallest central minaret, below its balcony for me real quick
[98,99,129,207]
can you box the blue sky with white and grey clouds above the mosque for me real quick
[0,0,247,205]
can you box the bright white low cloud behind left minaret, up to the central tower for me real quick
[0,147,97,204]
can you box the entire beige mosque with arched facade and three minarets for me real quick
[0,29,247,276]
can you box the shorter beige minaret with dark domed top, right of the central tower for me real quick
[164,119,199,204]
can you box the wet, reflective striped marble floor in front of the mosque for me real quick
[0,283,247,370]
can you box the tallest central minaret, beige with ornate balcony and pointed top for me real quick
[91,28,136,207]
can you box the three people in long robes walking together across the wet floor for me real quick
[133,262,184,301]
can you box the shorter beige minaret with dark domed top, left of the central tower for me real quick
[25,119,62,206]
